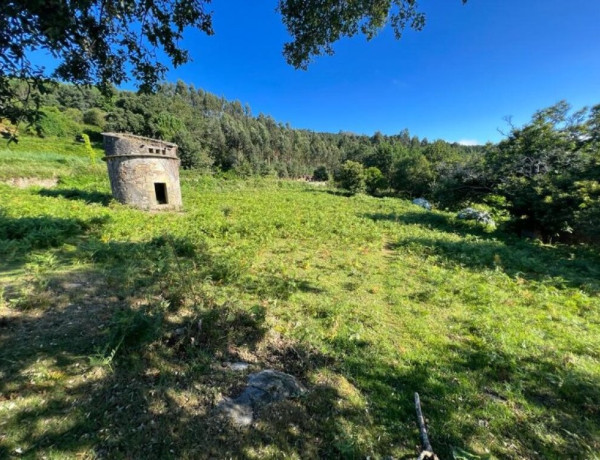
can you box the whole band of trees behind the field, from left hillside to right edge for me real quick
[0,81,600,241]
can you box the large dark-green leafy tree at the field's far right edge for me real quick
[488,101,600,240]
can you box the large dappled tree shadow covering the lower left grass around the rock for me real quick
[0,225,378,458]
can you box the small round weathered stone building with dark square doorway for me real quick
[102,133,182,211]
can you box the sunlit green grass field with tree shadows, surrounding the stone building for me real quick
[0,141,600,459]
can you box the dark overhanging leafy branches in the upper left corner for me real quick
[0,0,213,129]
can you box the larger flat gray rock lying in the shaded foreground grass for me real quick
[217,370,306,426]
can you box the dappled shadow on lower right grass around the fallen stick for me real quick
[330,326,600,459]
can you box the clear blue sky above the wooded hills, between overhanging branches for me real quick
[35,0,600,143]
